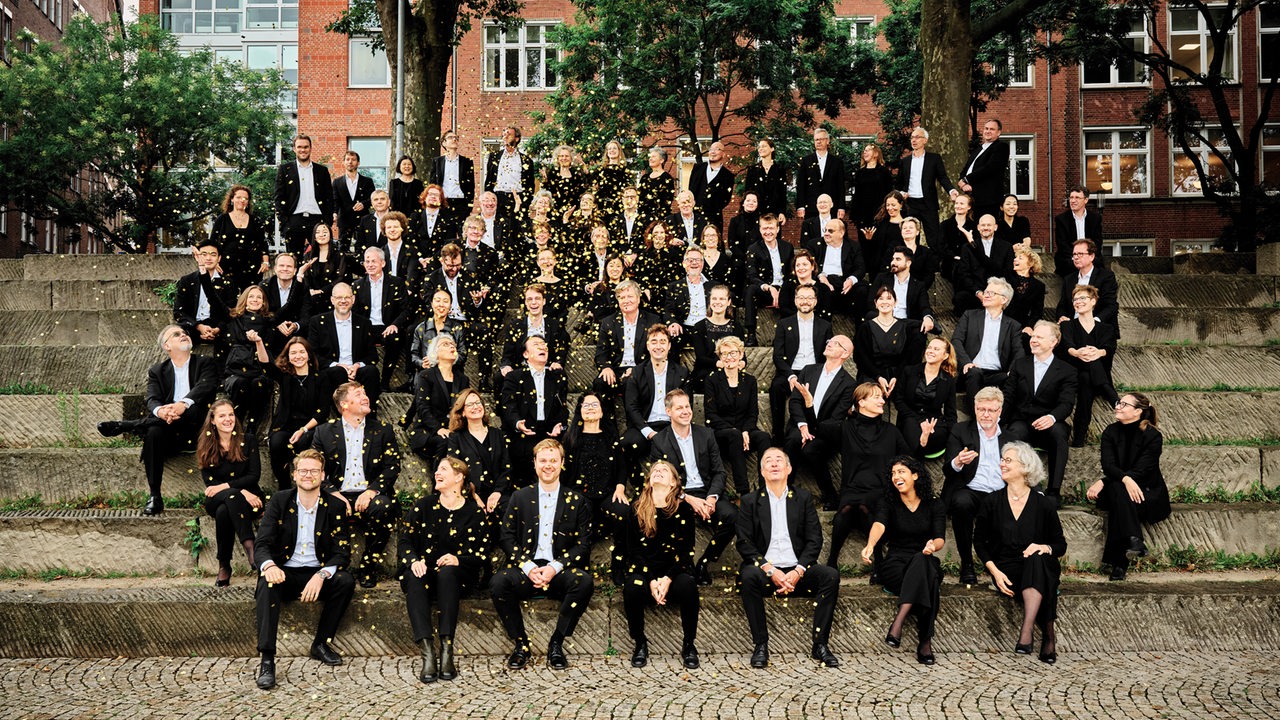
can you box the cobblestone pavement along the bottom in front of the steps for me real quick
[0,650,1280,720]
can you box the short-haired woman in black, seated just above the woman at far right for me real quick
[1057,284,1120,447]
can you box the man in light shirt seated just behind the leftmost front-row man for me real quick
[311,383,401,588]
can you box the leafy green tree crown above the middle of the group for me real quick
[524,0,874,161]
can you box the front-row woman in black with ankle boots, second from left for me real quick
[397,457,490,683]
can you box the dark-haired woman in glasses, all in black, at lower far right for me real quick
[1085,392,1170,580]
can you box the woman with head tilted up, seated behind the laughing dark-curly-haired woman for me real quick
[892,336,956,460]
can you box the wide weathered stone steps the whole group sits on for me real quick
[0,256,1280,656]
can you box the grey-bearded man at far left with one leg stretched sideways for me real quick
[97,325,219,515]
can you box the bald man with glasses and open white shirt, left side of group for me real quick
[302,283,381,407]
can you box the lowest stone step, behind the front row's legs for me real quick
[0,575,1280,673]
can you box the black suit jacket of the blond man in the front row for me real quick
[498,482,591,568]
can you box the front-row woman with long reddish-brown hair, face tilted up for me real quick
[622,460,701,670]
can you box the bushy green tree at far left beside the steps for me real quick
[0,15,289,251]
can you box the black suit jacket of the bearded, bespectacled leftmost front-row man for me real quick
[253,488,351,570]
